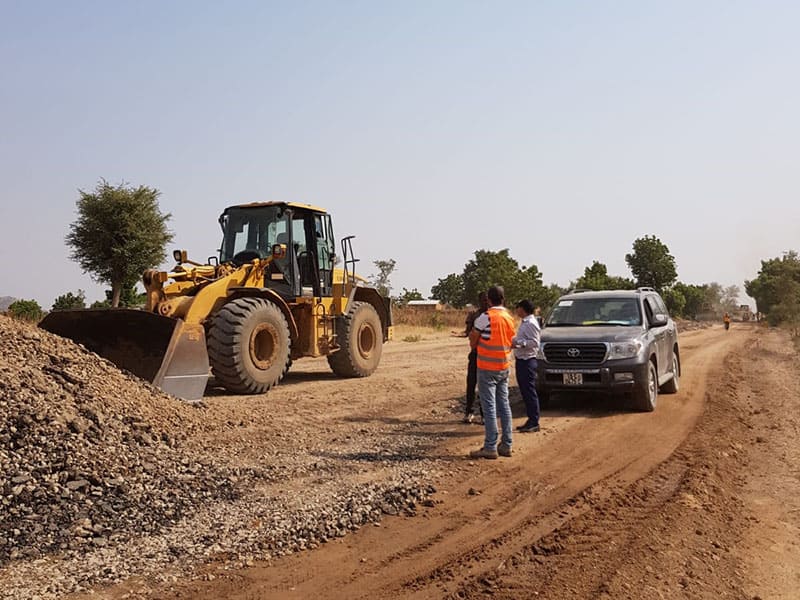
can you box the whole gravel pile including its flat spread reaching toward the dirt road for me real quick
[0,316,436,599]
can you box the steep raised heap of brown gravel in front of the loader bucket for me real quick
[0,316,242,566]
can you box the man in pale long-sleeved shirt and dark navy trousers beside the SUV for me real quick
[512,300,542,433]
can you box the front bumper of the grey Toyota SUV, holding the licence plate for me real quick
[537,360,648,394]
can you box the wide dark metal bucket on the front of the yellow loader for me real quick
[39,309,208,400]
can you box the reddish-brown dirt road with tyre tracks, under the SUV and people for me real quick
[134,327,800,599]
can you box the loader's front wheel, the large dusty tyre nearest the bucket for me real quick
[208,298,292,394]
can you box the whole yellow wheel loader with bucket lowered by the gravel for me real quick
[41,202,392,400]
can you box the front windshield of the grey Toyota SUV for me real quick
[546,298,642,327]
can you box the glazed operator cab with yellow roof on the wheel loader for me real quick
[219,202,336,299]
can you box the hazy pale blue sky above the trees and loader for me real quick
[0,0,800,308]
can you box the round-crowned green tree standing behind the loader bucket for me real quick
[66,180,173,307]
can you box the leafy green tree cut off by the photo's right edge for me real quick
[744,252,800,324]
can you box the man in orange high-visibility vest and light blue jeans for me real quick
[469,286,514,459]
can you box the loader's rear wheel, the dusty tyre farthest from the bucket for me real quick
[328,302,383,377]
